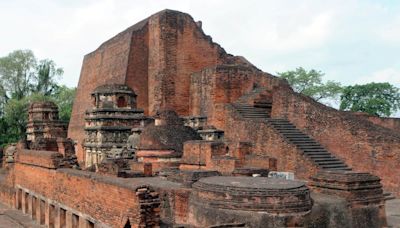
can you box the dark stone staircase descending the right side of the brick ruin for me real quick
[233,104,351,170]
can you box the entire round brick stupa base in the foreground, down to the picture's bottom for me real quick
[190,176,312,227]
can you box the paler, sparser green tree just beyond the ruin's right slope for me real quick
[278,67,342,101]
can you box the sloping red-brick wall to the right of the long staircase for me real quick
[272,86,400,196]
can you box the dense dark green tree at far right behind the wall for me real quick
[340,82,400,116]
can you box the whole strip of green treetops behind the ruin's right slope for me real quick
[278,67,400,117]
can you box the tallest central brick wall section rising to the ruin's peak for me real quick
[148,10,235,115]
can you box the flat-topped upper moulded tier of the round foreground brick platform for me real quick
[193,176,312,214]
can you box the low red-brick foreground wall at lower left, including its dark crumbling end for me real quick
[15,150,159,227]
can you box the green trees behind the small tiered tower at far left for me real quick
[0,50,76,146]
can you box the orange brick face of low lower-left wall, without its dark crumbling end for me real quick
[15,151,154,227]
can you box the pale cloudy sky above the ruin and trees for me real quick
[0,0,400,91]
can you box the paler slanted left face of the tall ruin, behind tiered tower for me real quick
[68,20,132,161]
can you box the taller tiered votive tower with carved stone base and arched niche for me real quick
[84,84,144,167]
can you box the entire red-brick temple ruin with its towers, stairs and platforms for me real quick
[0,10,400,228]
